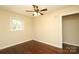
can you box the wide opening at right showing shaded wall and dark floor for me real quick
[62,13,79,54]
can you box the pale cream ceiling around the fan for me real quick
[0,5,71,16]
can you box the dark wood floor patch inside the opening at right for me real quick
[63,43,79,54]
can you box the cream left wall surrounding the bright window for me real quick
[0,9,32,49]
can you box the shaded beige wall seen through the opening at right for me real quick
[63,14,79,46]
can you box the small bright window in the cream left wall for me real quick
[10,19,23,31]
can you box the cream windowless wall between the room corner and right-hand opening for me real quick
[33,6,79,48]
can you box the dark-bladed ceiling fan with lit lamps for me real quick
[26,5,47,16]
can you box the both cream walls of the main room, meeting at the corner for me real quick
[0,6,79,48]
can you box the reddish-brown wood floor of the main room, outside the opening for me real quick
[0,40,62,54]
